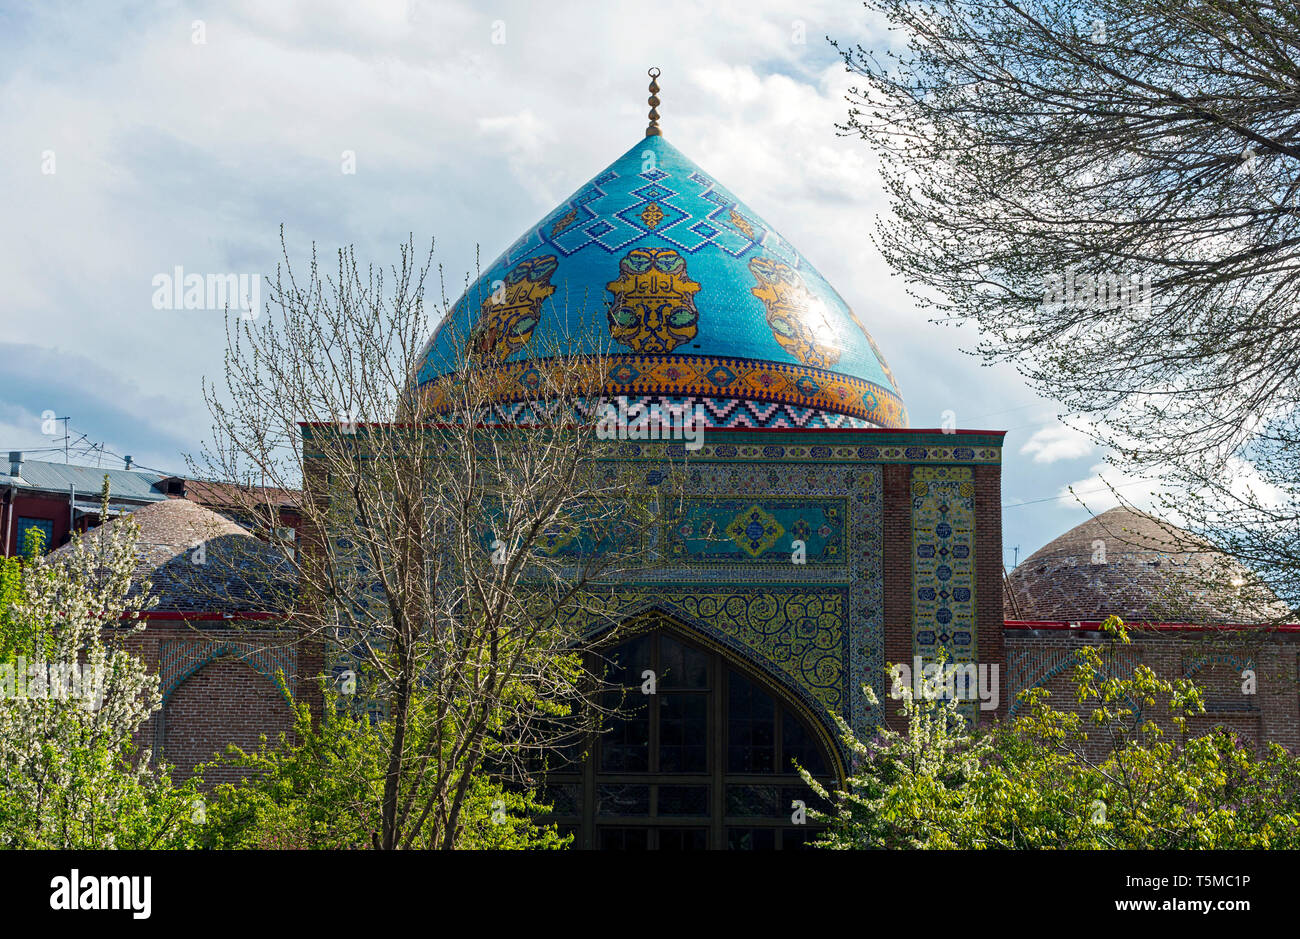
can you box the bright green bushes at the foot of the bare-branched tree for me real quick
[202,693,568,849]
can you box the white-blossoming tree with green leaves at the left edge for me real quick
[0,479,203,848]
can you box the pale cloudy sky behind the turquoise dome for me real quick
[0,0,1149,564]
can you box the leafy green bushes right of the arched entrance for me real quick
[801,618,1300,849]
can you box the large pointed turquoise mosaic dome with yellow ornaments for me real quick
[419,137,907,428]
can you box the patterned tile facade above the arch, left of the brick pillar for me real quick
[599,447,884,736]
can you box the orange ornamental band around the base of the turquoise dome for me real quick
[423,354,907,428]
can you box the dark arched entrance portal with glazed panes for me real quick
[546,628,833,851]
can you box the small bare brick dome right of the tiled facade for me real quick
[1005,507,1290,624]
